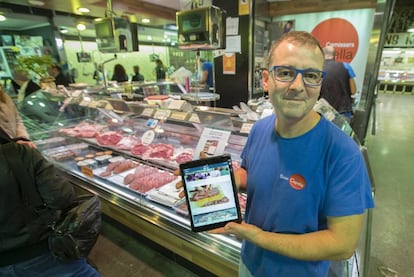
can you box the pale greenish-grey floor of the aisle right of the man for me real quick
[366,94,414,277]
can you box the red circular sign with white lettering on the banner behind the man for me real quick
[312,18,359,63]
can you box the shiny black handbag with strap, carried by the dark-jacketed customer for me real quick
[2,143,102,261]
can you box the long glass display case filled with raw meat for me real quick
[19,91,371,276]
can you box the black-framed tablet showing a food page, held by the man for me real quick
[180,154,242,232]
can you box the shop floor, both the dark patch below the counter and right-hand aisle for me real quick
[90,91,414,277]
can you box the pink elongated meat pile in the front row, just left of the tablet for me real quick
[129,171,178,193]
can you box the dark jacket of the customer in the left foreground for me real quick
[0,143,75,266]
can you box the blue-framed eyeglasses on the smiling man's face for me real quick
[269,65,326,86]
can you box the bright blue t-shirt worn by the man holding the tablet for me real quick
[241,115,374,277]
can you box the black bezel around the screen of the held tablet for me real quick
[180,154,242,232]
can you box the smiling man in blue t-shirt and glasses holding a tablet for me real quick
[210,31,374,277]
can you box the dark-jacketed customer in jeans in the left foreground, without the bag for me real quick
[0,135,100,277]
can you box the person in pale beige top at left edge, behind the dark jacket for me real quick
[0,84,36,148]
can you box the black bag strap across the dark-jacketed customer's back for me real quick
[1,142,44,207]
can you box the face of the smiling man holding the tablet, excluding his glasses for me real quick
[264,41,324,119]
